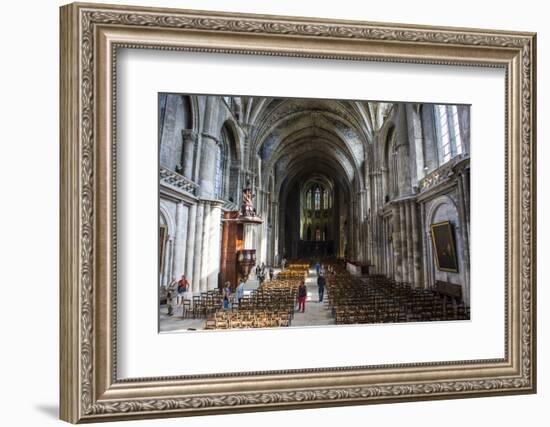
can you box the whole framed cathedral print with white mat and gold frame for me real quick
[60,4,536,423]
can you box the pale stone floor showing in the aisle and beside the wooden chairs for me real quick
[159,269,335,332]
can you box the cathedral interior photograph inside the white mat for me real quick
[157,93,470,333]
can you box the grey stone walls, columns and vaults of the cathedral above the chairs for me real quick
[159,94,470,332]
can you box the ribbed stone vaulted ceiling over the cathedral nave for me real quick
[239,97,393,199]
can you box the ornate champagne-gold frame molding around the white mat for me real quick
[60,4,536,423]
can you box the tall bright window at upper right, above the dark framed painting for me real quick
[434,105,463,164]
